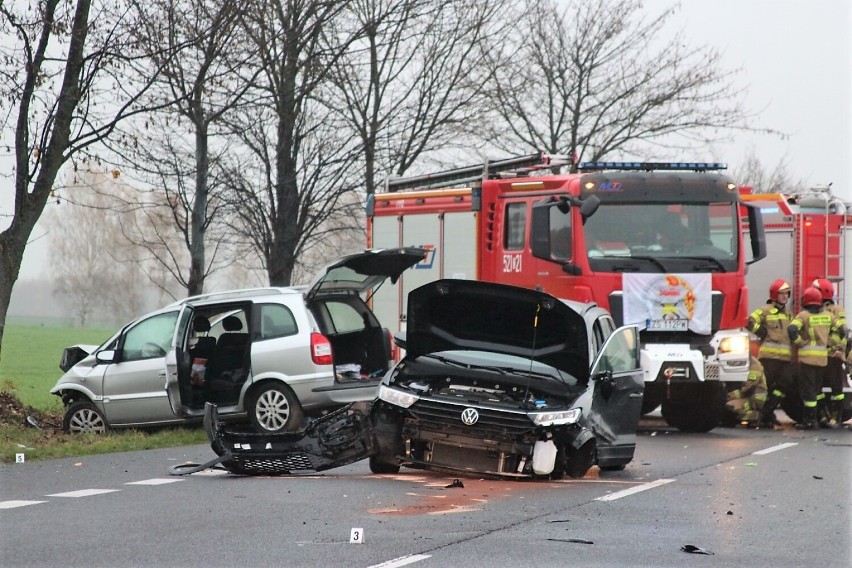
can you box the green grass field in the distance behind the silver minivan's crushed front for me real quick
[0,324,115,411]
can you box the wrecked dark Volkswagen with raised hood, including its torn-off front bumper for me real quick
[185,280,644,479]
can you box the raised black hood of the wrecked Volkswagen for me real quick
[405,280,589,378]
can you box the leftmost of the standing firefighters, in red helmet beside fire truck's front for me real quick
[748,278,793,428]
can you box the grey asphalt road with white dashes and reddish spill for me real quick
[0,419,852,568]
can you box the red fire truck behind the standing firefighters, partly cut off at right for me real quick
[740,186,852,421]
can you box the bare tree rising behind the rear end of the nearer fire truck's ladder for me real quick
[329,0,511,194]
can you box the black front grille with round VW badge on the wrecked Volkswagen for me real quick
[408,398,535,437]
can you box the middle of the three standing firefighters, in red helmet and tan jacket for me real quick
[787,287,846,430]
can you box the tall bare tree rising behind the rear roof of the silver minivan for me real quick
[229,0,372,285]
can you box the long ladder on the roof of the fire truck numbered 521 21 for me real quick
[385,152,571,192]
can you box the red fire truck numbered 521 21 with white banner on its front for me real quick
[367,154,766,432]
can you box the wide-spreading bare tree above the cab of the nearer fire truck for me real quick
[480,0,772,169]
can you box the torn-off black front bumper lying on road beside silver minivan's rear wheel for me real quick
[169,403,375,475]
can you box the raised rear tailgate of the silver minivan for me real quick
[305,247,427,300]
